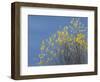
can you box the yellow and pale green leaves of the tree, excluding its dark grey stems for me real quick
[38,18,87,65]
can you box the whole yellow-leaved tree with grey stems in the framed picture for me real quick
[38,18,87,65]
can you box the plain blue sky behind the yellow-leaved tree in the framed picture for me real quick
[28,15,87,66]
